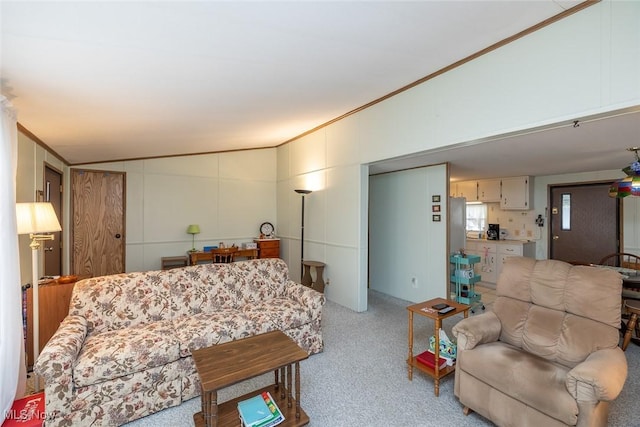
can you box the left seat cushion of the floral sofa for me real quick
[73,321,180,387]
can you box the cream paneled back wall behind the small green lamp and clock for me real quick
[74,148,279,271]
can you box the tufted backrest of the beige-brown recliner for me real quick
[493,257,622,368]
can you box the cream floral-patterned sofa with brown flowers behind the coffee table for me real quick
[34,258,325,426]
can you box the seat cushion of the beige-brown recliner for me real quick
[456,342,578,425]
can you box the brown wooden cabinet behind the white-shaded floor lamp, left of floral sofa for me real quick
[26,280,82,367]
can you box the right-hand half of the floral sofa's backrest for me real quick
[171,258,289,317]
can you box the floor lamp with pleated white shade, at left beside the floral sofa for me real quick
[16,202,62,391]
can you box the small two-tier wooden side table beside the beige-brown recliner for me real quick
[407,298,471,396]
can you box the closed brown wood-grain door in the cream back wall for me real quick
[71,169,125,277]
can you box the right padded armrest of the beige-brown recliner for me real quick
[565,347,628,402]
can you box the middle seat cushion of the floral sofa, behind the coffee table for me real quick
[173,309,260,357]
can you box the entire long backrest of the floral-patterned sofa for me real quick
[69,258,289,335]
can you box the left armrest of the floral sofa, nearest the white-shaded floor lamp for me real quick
[33,315,87,384]
